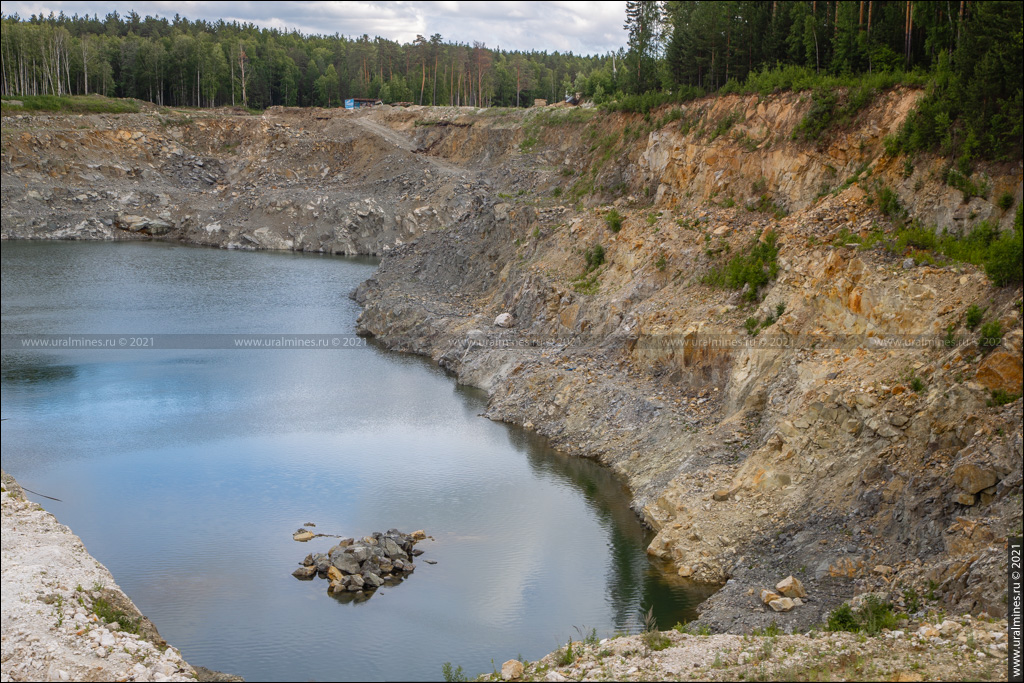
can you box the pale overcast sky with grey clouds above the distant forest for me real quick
[0,0,626,54]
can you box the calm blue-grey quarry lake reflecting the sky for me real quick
[2,242,707,680]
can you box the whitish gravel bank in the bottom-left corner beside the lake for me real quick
[0,471,242,681]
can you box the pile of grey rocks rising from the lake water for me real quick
[292,528,427,595]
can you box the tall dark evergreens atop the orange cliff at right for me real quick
[651,0,1024,160]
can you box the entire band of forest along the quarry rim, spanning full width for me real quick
[0,0,1024,158]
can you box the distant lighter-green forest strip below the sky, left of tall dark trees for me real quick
[0,12,614,109]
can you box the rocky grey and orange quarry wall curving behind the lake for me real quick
[3,90,1024,630]
